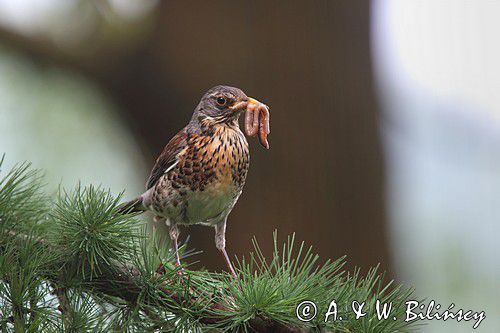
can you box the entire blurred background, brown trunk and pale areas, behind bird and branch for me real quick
[0,0,500,332]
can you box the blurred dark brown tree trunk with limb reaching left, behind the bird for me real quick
[0,0,390,269]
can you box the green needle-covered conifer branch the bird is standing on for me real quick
[0,159,411,332]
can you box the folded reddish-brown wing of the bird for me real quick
[146,128,187,190]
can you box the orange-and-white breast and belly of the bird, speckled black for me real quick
[154,124,249,224]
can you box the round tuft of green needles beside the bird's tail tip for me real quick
[49,185,139,278]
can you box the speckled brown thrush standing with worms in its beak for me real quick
[121,85,269,278]
